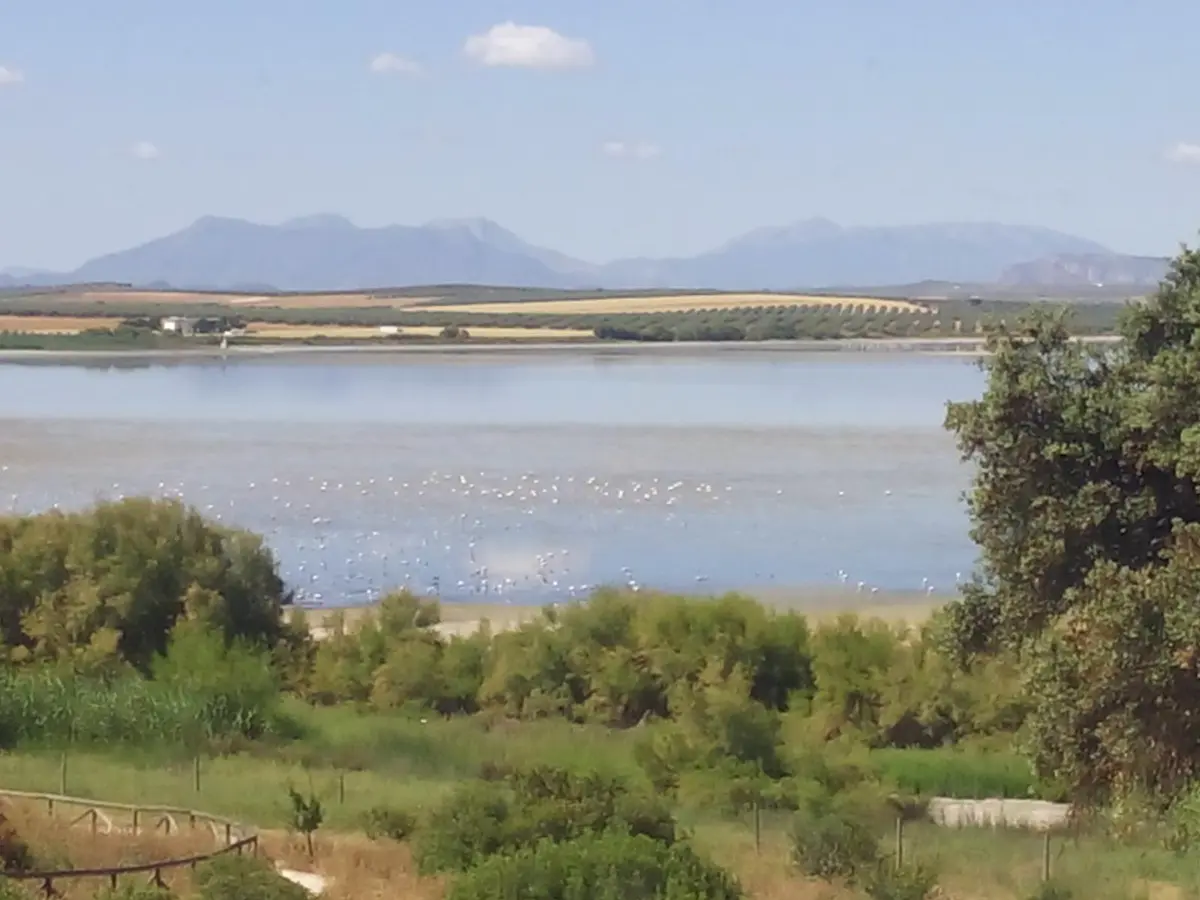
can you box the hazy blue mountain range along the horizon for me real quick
[0,214,1166,292]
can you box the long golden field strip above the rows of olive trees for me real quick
[422,294,926,316]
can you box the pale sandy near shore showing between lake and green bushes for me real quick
[290,586,953,640]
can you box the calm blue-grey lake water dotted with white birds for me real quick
[0,350,983,604]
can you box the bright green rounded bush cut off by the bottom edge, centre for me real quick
[446,832,743,900]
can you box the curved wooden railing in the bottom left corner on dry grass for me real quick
[0,788,258,898]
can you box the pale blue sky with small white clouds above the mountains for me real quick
[0,0,1200,268]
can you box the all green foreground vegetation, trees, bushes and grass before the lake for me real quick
[0,244,1200,900]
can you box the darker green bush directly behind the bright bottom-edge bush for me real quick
[416,767,677,871]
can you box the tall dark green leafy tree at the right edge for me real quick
[946,243,1200,798]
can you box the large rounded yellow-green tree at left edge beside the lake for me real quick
[0,499,289,671]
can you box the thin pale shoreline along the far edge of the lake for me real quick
[0,335,1120,365]
